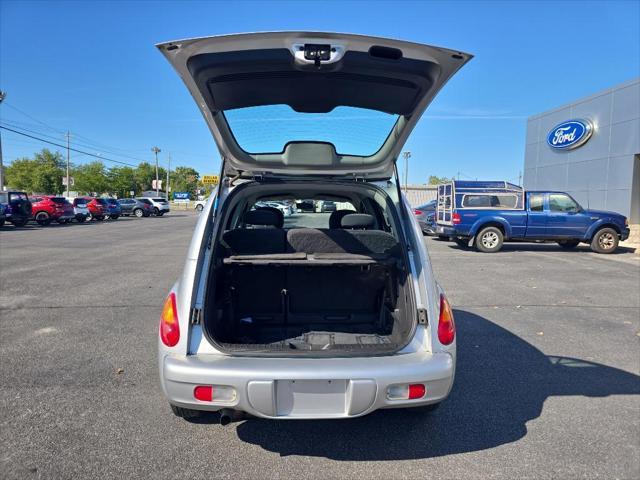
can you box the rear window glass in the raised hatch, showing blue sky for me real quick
[224,104,398,157]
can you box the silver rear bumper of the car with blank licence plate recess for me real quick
[160,352,455,419]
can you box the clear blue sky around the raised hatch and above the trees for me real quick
[0,0,640,183]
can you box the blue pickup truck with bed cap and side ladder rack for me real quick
[436,180,629,253]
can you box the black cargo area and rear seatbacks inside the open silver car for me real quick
[204,186,415,354]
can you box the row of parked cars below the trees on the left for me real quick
[0,191,170,227]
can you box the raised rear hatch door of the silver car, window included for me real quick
[158,32,471,179]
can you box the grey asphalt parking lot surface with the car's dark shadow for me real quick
[0,212,640,479]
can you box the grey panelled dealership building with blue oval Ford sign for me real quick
[524,78,640,241]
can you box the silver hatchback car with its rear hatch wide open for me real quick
[158,32,471,424]
